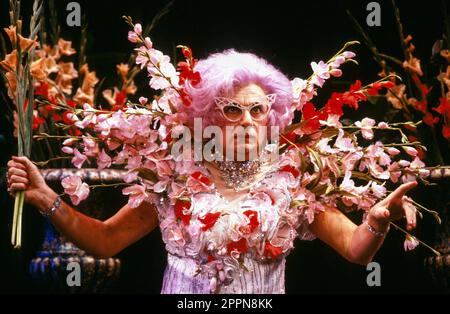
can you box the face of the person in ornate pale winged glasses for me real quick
[214,84,275,161]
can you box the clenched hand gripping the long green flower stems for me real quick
[7,156,50,206]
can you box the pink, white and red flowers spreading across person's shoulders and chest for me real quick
[0,1,439,291]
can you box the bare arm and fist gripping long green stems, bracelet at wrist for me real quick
[8,157,157,257]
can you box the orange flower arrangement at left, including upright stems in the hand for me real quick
[0,0,143,248]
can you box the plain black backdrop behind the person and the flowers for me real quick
[0,0,448,293]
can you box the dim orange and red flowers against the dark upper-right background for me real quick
[348,1,450,164]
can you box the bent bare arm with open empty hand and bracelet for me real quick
[310,183,416,265]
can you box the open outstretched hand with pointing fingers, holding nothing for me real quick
[367,182,417,230]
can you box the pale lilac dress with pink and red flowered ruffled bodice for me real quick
[157,151,315,294]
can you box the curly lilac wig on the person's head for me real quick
[185,49,293,130]
